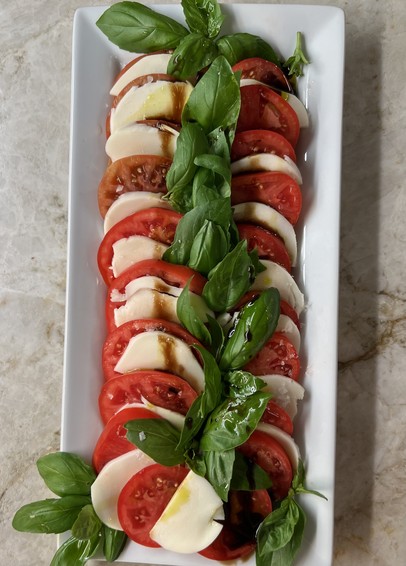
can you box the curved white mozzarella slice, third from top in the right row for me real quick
[233,202,297,266]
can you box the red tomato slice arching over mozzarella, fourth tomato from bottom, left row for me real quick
[102,318,199,379]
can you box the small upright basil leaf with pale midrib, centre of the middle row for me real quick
[188,220,229,276]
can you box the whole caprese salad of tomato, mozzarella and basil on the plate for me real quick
[14,0,326,566]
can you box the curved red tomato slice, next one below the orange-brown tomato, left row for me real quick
[97,208,182,285]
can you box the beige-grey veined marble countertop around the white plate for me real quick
[0,0,406,566]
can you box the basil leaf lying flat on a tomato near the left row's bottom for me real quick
[124,419,184,466]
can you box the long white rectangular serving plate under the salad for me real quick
[61,4,344,566]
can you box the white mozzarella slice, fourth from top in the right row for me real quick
[251,259,304,314]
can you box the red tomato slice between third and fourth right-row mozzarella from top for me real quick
[237,224,292,273]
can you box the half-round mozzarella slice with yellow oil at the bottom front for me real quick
[149,471,224,554]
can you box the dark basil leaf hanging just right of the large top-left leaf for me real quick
[168,33,218,80]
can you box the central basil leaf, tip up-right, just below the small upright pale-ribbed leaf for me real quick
[203,240,254,312]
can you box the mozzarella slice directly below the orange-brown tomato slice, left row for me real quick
[104,191,172,234]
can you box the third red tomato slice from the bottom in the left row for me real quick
[99,370,197,423]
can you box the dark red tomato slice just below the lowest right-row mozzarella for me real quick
[238,430,293,499]
